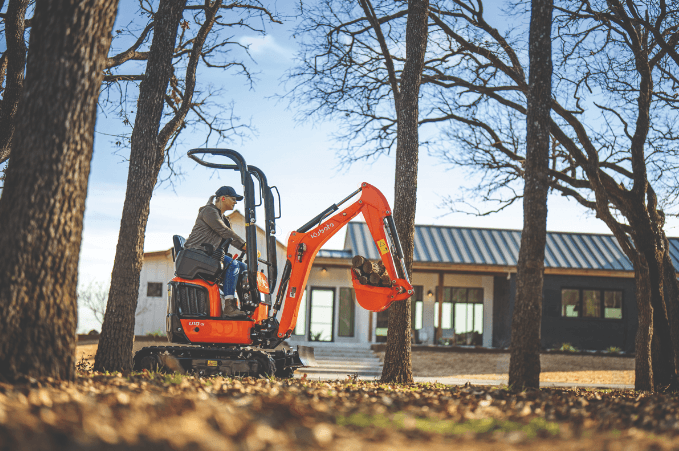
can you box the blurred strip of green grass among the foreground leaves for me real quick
[337,412,560,438]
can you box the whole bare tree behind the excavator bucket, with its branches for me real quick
[288,0,429,383]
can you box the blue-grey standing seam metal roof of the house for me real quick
[318,222,679,271]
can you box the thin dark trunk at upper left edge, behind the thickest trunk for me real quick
[0,0,28,163]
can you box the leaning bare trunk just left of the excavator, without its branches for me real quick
[94,0,186,371]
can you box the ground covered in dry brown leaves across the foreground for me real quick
[0,371,679,450]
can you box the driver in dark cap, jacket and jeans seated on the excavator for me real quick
[184,186,247,318]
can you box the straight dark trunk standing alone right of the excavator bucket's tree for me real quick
[509,0,553,390]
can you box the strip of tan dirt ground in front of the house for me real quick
[77,341,634,385]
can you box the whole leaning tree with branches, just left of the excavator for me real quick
[94,0,275,371]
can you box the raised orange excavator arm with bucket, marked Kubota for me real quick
[272,183,413,339]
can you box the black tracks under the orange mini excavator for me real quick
[133,346,313,378]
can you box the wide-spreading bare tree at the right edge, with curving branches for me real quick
[423,0,679,390]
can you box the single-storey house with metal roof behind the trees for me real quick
[135,219,679,352]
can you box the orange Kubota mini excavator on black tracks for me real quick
[134,149,413,377]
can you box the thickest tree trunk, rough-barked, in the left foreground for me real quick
[0,0,118,381]
